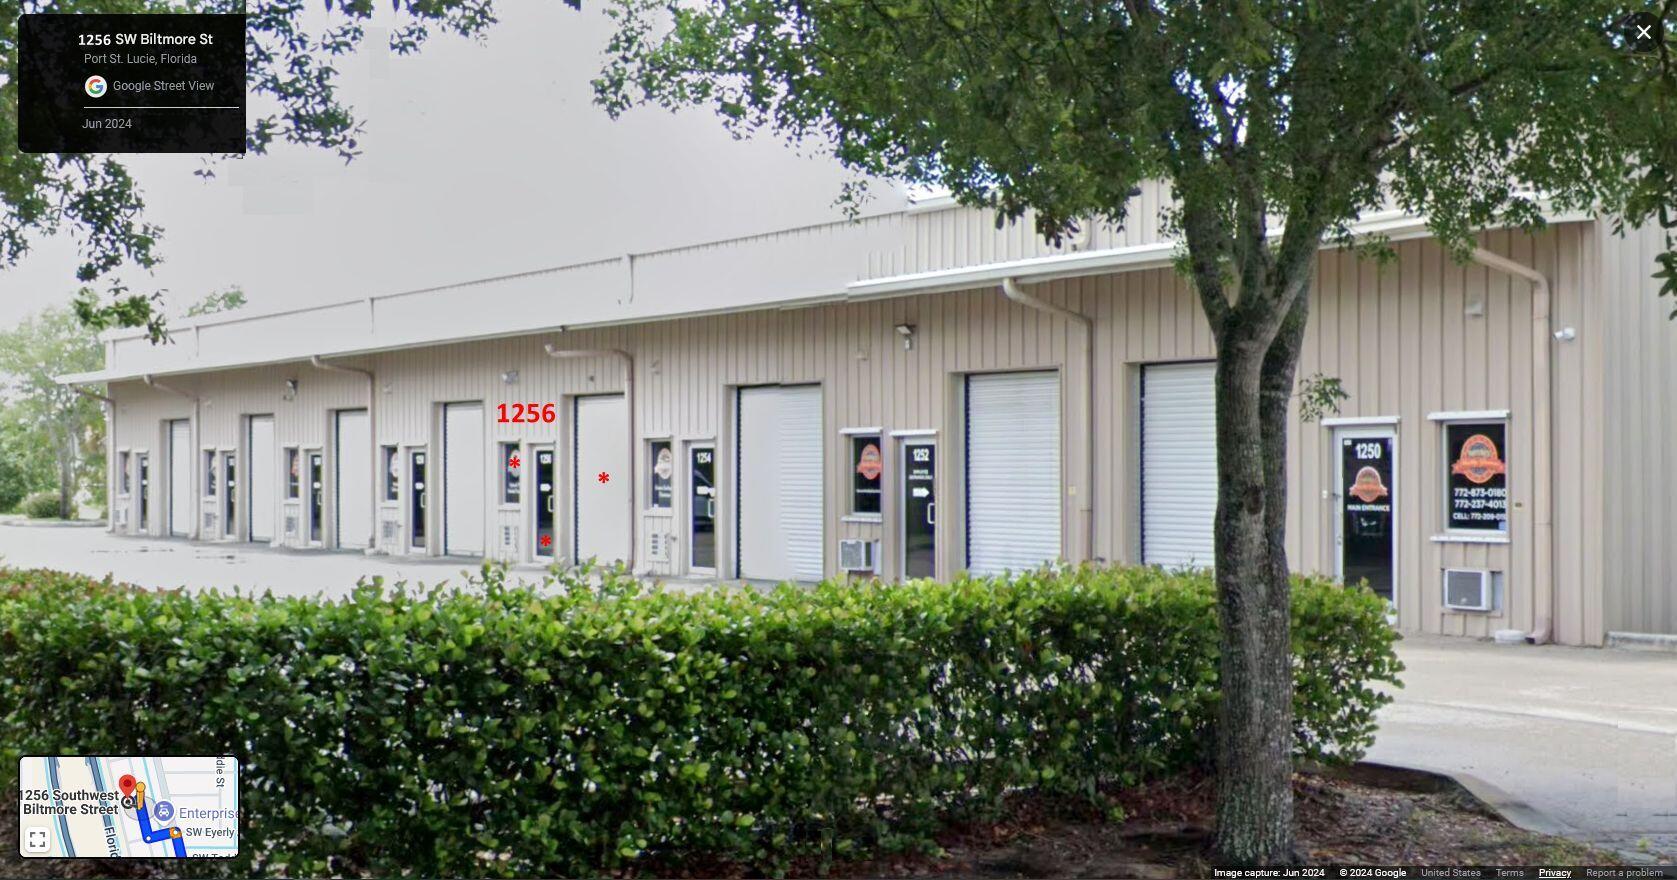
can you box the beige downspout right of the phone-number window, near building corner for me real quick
[1471,245,1555,645]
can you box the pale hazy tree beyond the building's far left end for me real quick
[0,308,104,520]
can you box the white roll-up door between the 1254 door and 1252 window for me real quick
[735,386,825,580]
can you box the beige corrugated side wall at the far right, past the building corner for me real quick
[1591,225,1677,634]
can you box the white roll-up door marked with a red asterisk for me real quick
[572,394,632,565]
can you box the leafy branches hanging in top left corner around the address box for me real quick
[0,0,580,339]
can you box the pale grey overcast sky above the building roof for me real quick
[0,0,901,324]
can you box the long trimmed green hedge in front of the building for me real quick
[0,568,1400,875]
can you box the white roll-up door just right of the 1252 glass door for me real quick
[966,372,1060,575]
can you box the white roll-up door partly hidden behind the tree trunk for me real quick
[1140,364,1218,568]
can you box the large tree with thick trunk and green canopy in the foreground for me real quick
[597,0,1677,863]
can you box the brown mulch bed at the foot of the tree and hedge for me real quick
[0,766,1622,880]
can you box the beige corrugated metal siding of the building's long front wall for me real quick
[95,222,1609,642]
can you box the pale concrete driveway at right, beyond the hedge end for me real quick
[1368,635,1677,860]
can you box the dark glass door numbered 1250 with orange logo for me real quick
[1340,436,1397,600]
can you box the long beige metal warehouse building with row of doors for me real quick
[65,188,1677,644]
